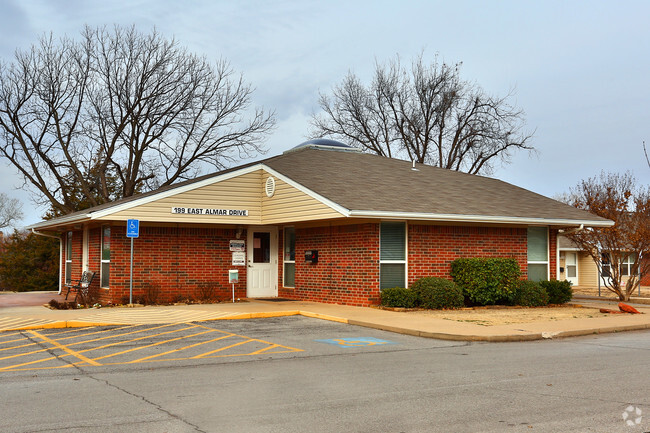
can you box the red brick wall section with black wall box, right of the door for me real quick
[279,224,379,306]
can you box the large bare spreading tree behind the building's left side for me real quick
[0,27,274,214]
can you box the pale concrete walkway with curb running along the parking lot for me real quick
[0,295,650,341]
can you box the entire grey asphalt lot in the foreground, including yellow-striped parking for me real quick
[0,315,650,433]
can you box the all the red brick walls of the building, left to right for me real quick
[62,222,557,306]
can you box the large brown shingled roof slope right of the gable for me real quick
[265,149,607,222]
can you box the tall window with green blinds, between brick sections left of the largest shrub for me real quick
[379,222,406,290]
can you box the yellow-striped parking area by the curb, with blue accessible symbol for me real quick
[0,316,462,375]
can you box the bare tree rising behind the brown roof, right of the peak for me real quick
[310,55,533,174]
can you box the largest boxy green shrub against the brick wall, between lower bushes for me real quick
[451,258,521,305]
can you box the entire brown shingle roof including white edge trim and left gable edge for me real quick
[31,148,612,228]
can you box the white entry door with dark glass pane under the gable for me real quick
[246,227,278,298]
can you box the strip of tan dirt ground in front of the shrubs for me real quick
[411,305,604,326]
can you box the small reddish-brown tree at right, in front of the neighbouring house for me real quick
[565,172,650,301]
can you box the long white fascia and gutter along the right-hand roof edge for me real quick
[349,210,614,227]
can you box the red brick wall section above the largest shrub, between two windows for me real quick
[408,224,528,285]
